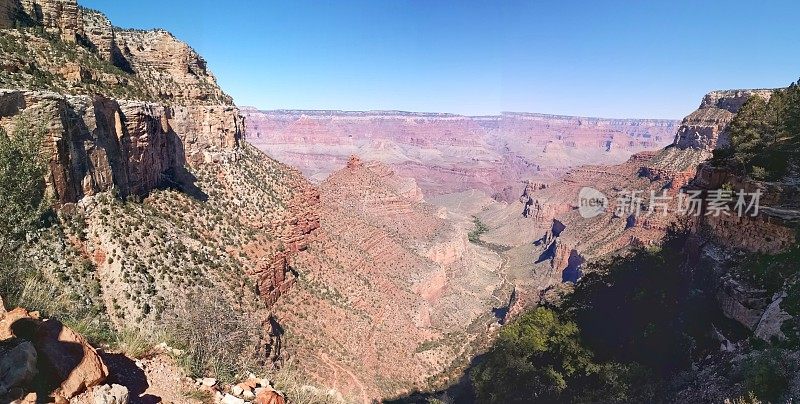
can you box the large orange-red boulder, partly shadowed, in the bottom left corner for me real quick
[34,320,108,399]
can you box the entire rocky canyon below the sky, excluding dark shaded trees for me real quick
[0,0,800,403]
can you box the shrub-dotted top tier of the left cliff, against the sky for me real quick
[0,0,233,105]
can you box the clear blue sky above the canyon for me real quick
[78,0,800,118]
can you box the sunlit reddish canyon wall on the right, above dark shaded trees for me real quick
[475,90,799,326]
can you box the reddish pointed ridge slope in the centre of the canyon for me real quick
[274,157,507,401]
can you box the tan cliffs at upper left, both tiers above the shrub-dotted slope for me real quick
[0,0,244,204]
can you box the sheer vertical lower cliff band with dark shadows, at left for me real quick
[0,90,244,204]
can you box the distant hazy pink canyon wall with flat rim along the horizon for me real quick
[243,108,677,195]
